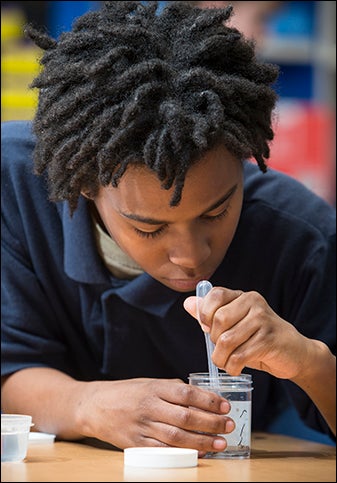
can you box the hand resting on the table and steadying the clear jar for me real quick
[77,378,234,456]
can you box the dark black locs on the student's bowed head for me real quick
[26,1,278,213]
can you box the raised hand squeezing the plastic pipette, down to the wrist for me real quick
[184,287,313,379]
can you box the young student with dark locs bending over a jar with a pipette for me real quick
[1,1,336,456]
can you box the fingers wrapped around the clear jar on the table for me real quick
[124,380,235,455]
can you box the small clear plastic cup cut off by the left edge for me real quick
[1,414,33,462]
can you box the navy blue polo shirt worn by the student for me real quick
[1,121,336,434]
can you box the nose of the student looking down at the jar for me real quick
[169,230,211,269]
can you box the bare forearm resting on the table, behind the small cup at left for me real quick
[1,368,89,439]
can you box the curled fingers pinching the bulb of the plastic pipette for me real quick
[184,287,276,375]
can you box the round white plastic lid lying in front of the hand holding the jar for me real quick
[124,447,198,468]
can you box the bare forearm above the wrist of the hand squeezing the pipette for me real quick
[292,340,336,435]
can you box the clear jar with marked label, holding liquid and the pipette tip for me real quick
[189,372,253,459]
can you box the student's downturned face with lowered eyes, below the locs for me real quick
[94,146,243,292]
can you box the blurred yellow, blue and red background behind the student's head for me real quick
[1,0,336,205]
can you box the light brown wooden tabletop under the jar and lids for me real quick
[1,433,336,482]
